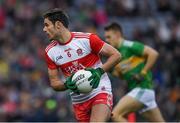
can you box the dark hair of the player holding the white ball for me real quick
[43,8,69,28]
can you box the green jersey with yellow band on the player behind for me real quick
[118,40,153,90]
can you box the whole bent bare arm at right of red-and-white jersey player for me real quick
[100,44,121,71]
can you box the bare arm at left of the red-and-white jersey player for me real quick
[48,69,66,91]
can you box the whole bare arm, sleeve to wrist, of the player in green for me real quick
[142,46,159,73]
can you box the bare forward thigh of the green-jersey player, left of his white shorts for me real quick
[113,95,144,116]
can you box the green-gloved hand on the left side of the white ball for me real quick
[64,74,80,94]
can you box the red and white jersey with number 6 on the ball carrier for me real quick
[45,32,111,103]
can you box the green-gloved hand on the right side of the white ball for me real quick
[85,67,104,88]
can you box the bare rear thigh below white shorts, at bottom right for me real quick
[142,108,164,122]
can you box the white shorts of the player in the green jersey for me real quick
[127,87,157,113]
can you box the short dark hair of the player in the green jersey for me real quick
[104,22,123,35]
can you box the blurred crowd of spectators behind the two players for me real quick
[0,0,180,122]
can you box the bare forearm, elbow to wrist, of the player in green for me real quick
[142,50,159,72]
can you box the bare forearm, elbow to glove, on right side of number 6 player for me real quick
[102,52,121,72]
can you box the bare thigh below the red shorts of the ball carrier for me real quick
[90,104,111,122]
